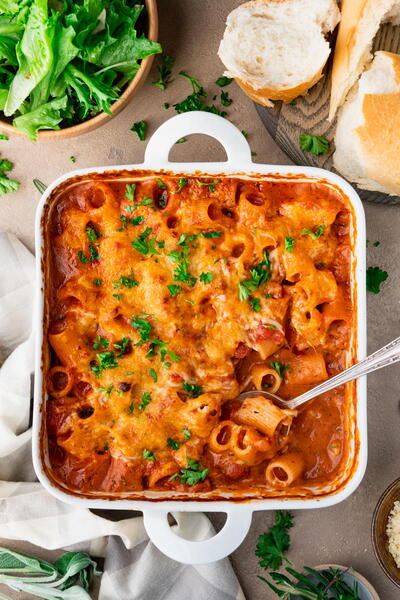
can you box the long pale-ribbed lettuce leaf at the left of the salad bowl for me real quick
[4,0,54,117]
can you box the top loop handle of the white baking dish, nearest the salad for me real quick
[143,111,254,171]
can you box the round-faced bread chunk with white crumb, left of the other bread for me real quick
[218,0,340,106]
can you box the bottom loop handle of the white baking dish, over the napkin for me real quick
[143,511,252,565]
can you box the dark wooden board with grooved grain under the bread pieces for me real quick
[256,25,400,204]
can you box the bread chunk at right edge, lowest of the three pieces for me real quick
[333,52,400,195]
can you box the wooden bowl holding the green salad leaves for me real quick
[0,0,158,140]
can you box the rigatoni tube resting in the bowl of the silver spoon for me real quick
[236,396,297,439]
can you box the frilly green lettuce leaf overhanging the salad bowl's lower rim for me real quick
[13,95,68,140]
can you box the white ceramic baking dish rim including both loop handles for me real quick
[33,112,367,564]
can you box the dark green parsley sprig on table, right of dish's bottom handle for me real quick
[255,510,293,569]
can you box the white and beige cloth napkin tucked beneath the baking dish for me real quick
[0,233,244,600]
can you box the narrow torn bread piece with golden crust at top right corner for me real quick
[329,0,400,121]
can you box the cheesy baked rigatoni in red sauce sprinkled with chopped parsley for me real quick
[42,171,355,499]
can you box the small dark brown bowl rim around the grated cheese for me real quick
[372,478,400,587]
